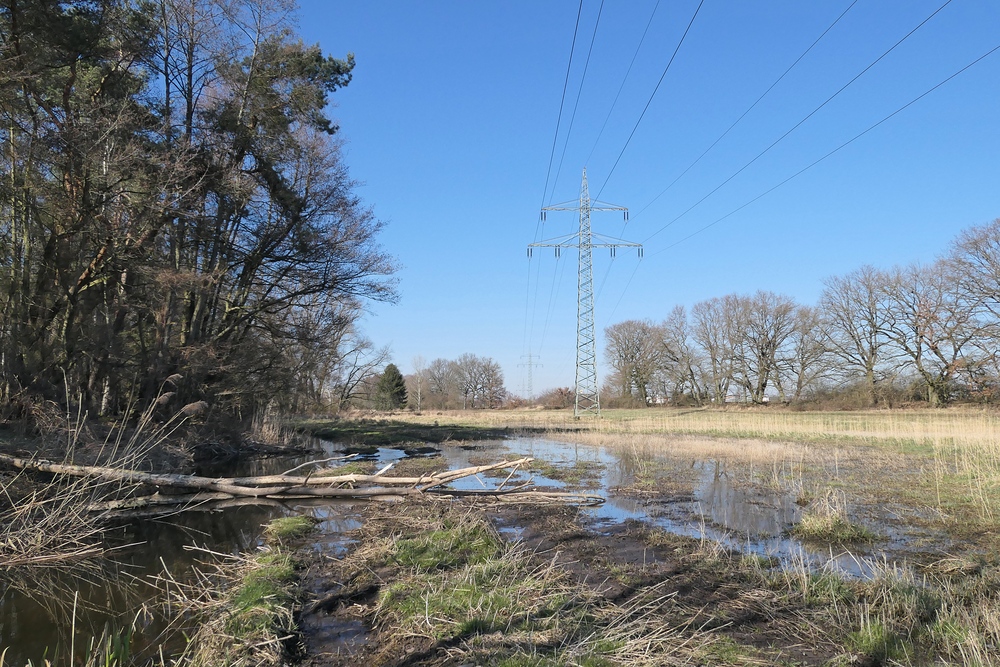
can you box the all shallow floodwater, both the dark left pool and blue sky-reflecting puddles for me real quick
[0,438,908,667]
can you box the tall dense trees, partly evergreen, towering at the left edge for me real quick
[0,0,395,414]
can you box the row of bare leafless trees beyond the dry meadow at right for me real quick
[605,219,1000,406]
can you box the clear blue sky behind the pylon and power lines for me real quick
[299,0,1000,393]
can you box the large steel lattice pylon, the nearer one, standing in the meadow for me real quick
[528,167,642,417]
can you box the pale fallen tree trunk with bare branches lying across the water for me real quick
[0,454,603,512]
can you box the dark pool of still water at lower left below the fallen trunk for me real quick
[0,505,289,665]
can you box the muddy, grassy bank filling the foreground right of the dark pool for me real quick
[299,501,1000,667]
